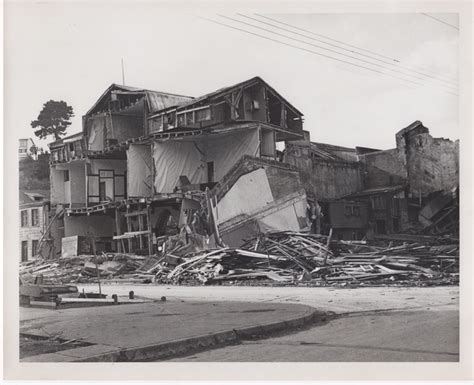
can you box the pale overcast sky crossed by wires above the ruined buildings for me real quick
[4,2,460,149]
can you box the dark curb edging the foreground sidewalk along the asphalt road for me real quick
[70,308,326,362]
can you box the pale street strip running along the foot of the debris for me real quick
[77,284,459,313]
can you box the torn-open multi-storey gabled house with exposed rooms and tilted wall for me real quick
[49,77,306,254]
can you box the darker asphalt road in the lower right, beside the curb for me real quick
[171,309,459,362]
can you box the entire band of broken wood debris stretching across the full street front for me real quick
[20,232,459,286]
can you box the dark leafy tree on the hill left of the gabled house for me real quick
[31,100,74,140]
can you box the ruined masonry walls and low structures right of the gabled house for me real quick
[285,121,459,239]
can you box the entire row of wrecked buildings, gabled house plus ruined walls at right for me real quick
[49,77,459,255]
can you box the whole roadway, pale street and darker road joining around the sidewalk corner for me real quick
[75,285,459,362]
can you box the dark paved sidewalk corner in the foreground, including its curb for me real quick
[20,300,324,362]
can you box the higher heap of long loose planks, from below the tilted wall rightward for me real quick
[159,232,459,285]
